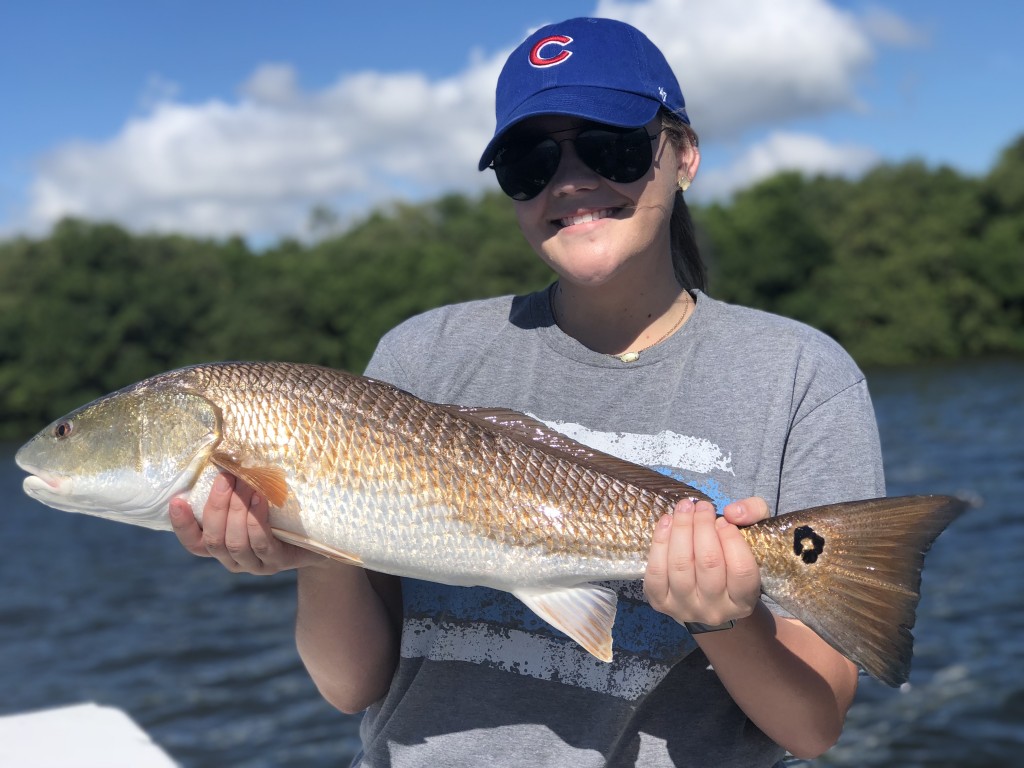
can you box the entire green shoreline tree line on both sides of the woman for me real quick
[0,135,1024,440]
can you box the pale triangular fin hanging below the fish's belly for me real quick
[512,584,618,662]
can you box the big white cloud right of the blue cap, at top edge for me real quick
[598,0,873,140]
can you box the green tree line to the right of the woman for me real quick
[695,151,1024,365]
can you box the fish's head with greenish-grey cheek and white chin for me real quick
[14,382,221,528]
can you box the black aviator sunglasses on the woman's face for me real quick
[490,126,662,201]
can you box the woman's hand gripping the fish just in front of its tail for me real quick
[644,497,768,626]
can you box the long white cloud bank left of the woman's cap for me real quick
[24,61,501,237]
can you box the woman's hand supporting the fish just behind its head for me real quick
[170,474,328,575]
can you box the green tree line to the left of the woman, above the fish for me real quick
[0,195,552,439]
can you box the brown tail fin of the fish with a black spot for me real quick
[742,496,967,687]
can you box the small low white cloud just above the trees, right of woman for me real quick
[693,132,881,200]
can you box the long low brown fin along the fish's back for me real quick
[440,406,712,502]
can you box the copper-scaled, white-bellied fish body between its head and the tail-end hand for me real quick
[152,364,702,588]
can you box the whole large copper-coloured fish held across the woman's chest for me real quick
[15,362,964,685]
